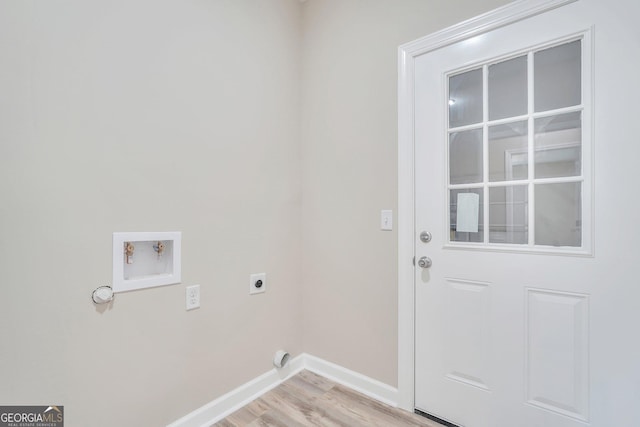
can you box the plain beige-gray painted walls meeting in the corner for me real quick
[0,0,504,427]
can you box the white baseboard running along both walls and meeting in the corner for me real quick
[167,353,398,427]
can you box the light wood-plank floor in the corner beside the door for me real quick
[212,371,442,427]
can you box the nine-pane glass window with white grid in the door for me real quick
[446,39,590,252]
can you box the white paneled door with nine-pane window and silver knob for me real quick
[413,0,640,427]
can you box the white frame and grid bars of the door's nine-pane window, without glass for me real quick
[442,33,593,256]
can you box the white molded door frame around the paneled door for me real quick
[397,0,578,412]
